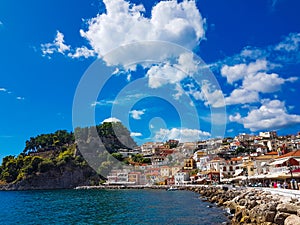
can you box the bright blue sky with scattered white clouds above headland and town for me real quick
[0,0,300,158]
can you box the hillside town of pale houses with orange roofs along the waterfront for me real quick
[105,131,300,189]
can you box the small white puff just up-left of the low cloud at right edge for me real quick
[225,89,259,105]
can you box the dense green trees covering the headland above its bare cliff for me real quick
[0,123,139,184]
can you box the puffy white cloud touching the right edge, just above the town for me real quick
[229,99,300,131]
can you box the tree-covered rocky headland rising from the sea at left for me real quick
[0,123,136,190]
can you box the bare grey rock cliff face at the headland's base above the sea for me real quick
[0,165,101,190]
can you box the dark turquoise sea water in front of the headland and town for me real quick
[0,190,227,225]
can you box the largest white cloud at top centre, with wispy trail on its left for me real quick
[41,0,205,66]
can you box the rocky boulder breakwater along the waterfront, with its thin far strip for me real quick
[78,185,300,225]
